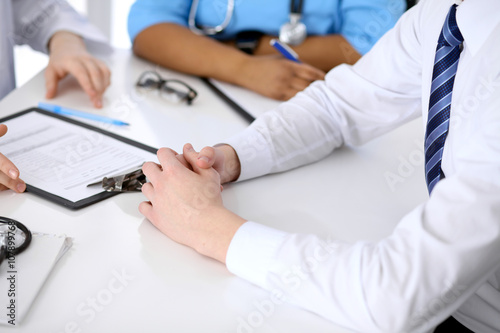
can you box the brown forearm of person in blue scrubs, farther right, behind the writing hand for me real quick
[255,35,361,72]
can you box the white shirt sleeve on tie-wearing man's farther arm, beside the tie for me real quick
[226,3,422,180]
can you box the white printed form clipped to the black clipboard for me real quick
[0,112,157,202]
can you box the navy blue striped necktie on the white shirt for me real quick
[425,5,464,194]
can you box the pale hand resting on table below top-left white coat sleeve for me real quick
[45,31,111,108]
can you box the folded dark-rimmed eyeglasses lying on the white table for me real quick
[136,71,198,105]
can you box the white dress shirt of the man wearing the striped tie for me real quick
[226,0,500,333]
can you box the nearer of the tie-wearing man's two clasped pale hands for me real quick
[139,144,245,262]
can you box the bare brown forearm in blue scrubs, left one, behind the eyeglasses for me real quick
[133,23,249,85]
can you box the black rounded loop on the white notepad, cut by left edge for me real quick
[0,216,31,265]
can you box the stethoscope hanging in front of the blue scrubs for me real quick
[188,0,307,45]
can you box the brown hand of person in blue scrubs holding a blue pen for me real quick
[238,56,325,101]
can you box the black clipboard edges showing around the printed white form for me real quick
[0,107,158,210]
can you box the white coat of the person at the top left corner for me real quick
[0,0,109,99]
